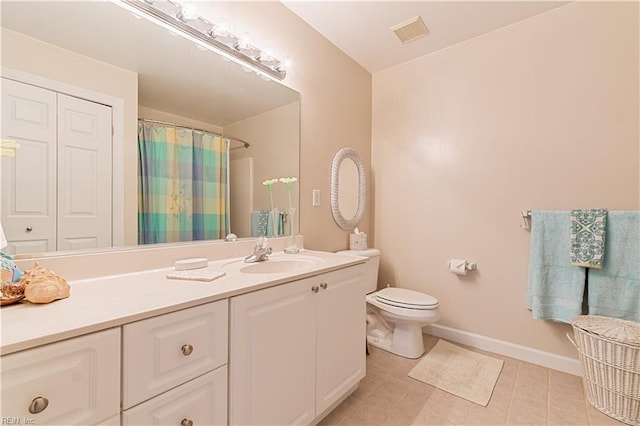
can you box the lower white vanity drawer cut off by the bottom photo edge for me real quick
[122,366,227,426]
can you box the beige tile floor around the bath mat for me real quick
[320,335,624,426]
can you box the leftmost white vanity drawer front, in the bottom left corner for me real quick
[1,328,120,425]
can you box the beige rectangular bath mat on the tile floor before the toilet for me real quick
[409,340,504,407]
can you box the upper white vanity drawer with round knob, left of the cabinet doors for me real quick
[122,299,228,409]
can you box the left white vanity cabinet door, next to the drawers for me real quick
[229,279,318,425]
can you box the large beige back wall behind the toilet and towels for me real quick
[372,2,640,356]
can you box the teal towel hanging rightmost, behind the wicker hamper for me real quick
[587,211,640,322]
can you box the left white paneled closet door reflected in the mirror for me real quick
[0,78,57,253]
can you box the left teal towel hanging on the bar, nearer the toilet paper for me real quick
[527,211,585,323]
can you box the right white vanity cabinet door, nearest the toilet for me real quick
[316,265,366,414]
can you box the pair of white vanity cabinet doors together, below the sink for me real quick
[229,265,366,425]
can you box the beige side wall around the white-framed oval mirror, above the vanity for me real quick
[200,1,373,251]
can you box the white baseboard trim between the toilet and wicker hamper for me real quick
[425,324,582,376]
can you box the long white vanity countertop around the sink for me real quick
[0,250,366,355]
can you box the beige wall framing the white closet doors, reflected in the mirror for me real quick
[2,28,138,245]
